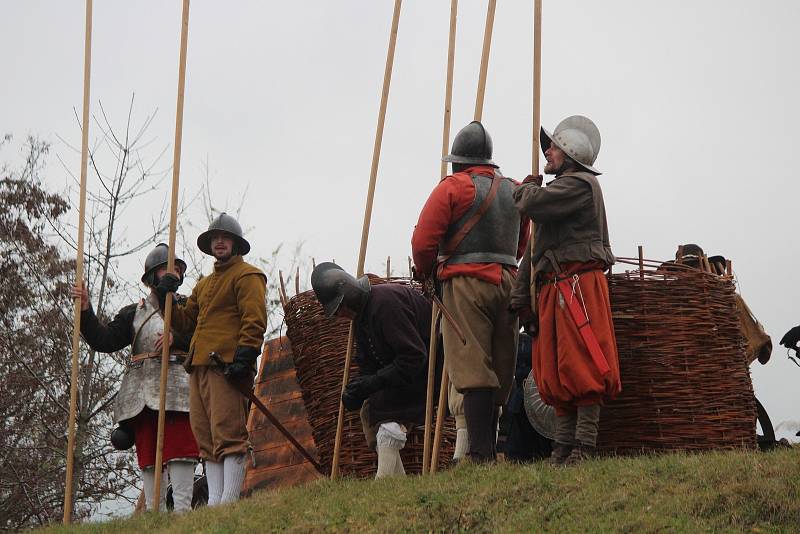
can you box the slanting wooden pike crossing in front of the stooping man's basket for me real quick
[331,0,403,479]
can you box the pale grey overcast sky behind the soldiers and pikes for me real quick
[0,0,800,432]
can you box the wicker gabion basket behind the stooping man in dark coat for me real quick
[284,275,456,478]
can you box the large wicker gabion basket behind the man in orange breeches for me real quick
[598,259,756,454]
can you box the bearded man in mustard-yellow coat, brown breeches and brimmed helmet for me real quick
[157,213,267,506]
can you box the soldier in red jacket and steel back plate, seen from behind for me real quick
[411,121,529,462]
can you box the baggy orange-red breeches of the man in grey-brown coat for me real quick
[533,263,622,415]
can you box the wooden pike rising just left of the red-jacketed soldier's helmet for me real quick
[422,0,460,474]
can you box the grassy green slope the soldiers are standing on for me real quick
[49,449,800,534]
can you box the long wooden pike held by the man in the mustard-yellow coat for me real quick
[153,0,189,511]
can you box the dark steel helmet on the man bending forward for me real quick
[311,261,370,317]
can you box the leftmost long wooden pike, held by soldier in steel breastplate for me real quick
[64,0,92,524]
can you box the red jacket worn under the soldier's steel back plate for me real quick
[411,165,530,285]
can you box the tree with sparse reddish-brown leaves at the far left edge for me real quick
[0,137,137,529]
